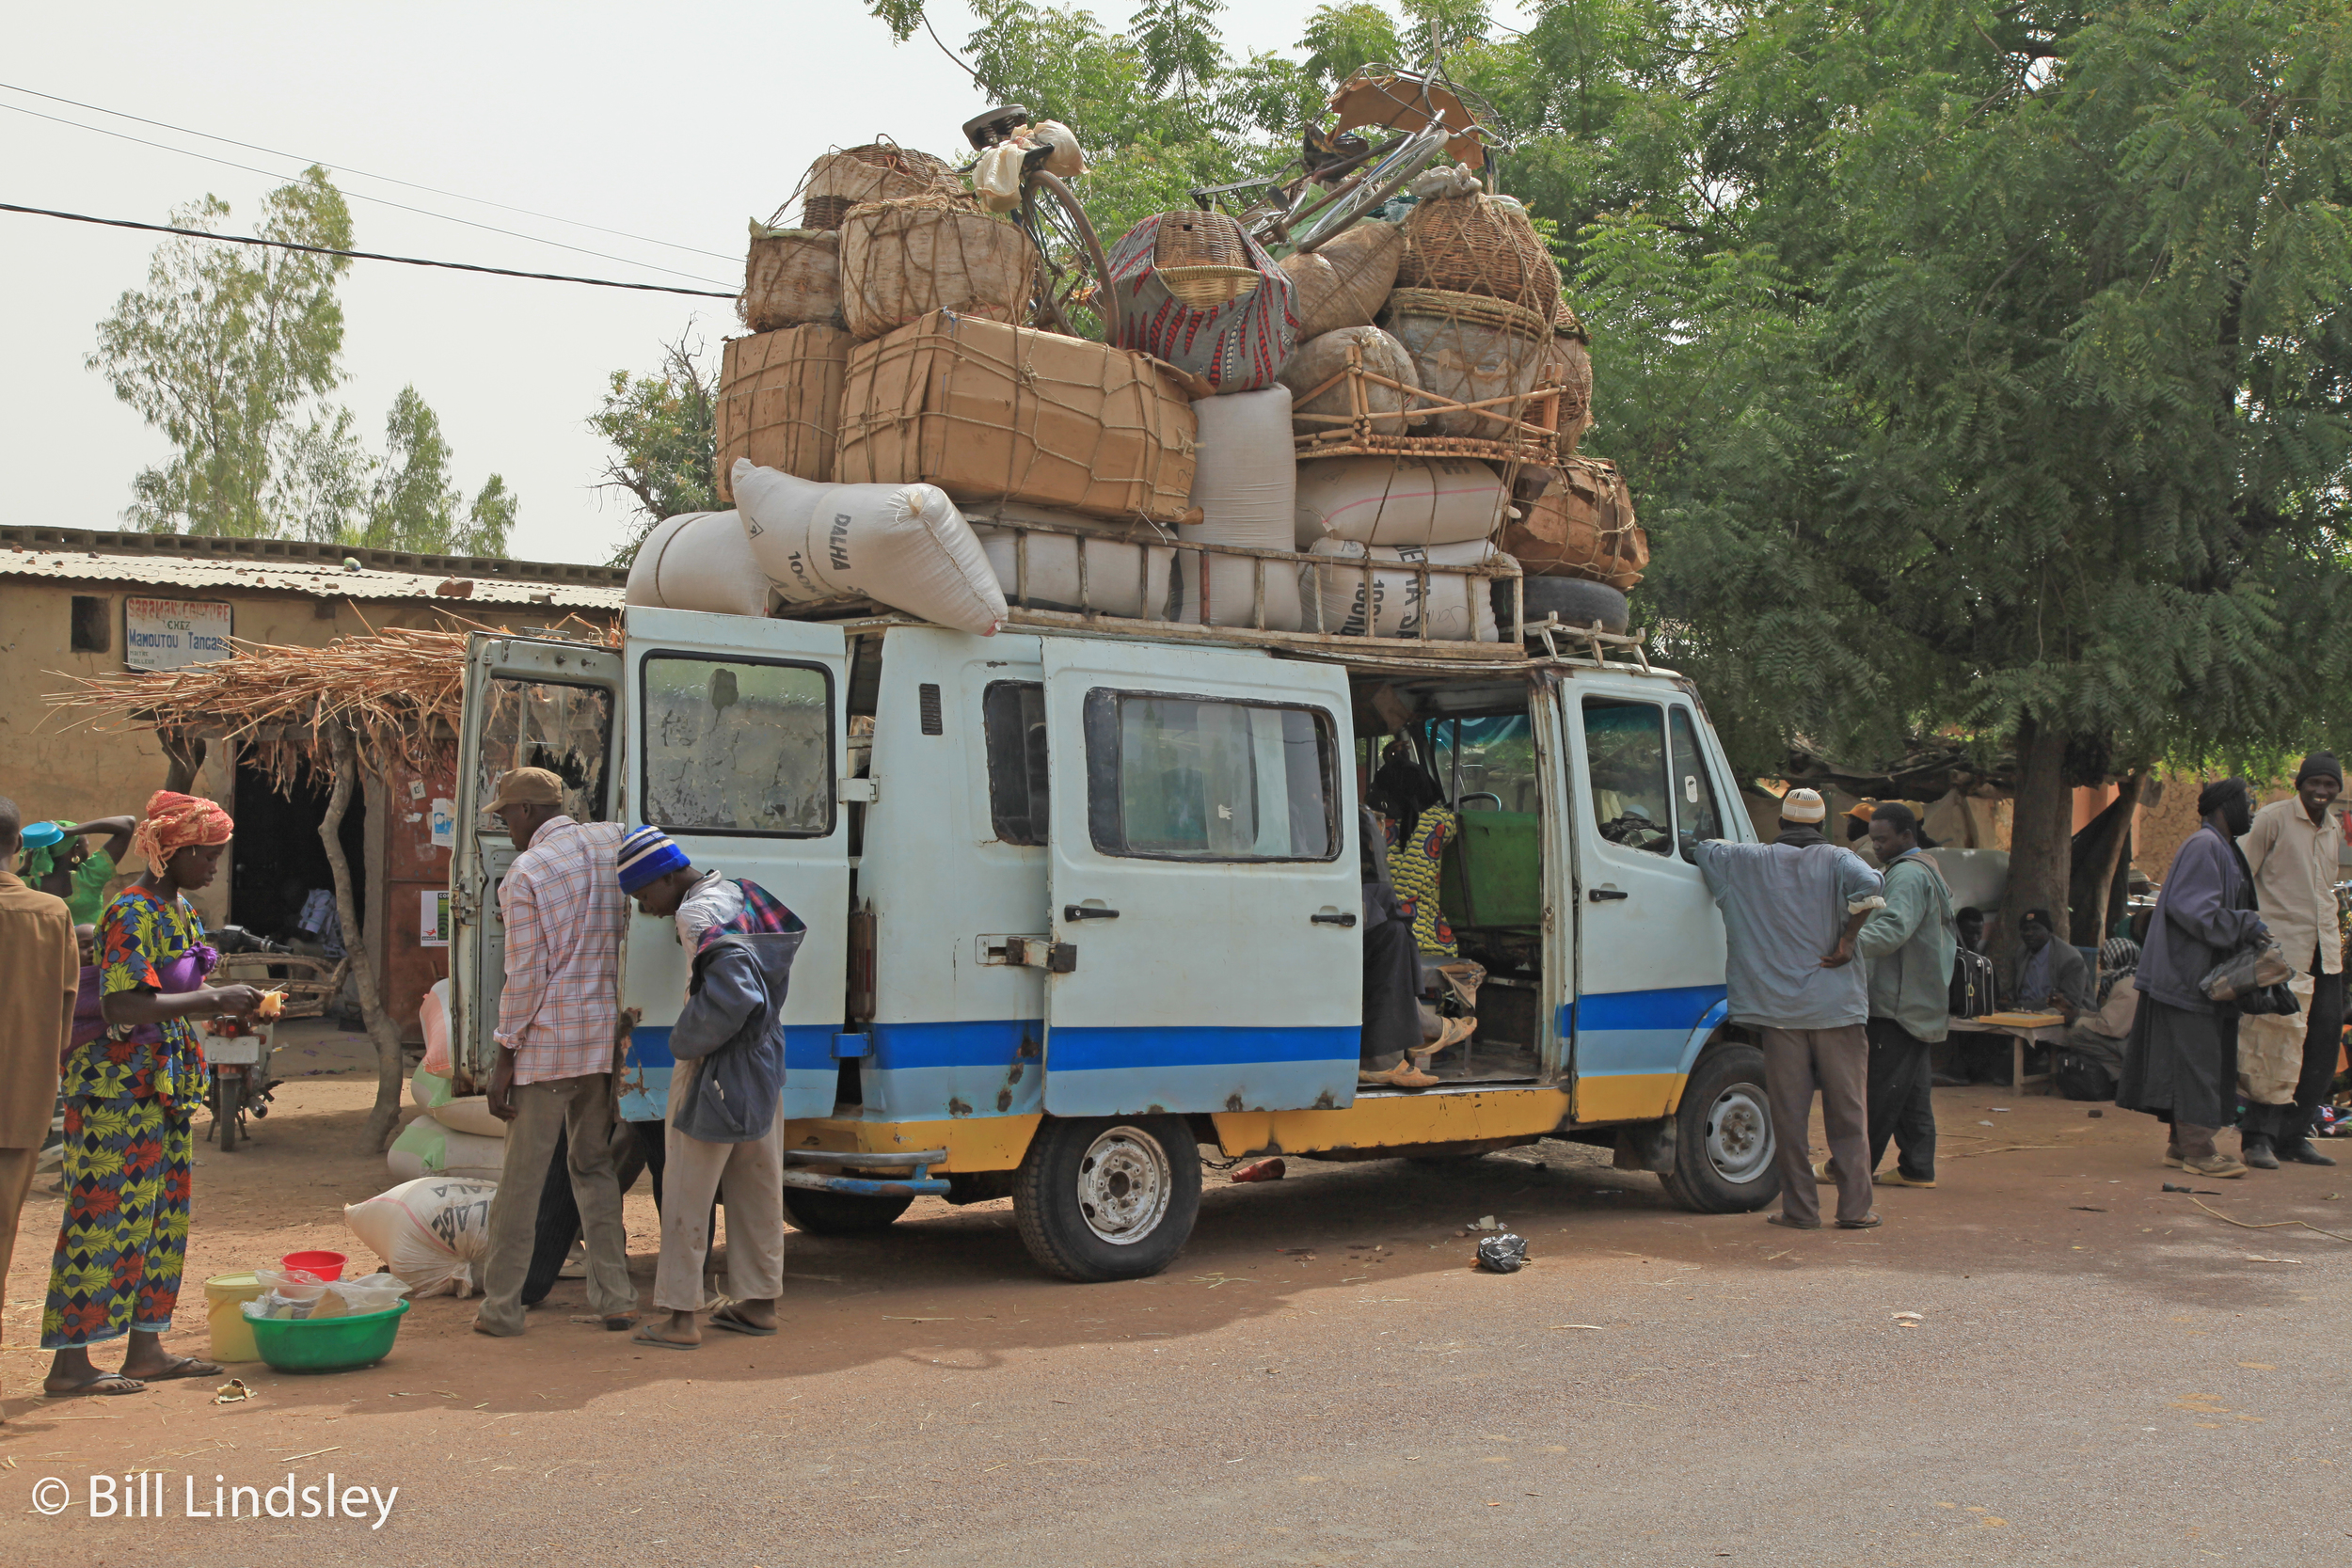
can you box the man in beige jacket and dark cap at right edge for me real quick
[2237,752,2345,1171]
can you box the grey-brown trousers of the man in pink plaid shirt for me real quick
[473,1072,638,1336]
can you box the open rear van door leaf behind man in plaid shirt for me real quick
[452,632,621,1093]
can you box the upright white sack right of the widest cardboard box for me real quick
[1176,386,1301,632]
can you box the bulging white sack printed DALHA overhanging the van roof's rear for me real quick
[734,460,1002,637]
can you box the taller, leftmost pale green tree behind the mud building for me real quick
[87,165,351,536]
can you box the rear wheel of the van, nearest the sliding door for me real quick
[1014,1117,1200,1284]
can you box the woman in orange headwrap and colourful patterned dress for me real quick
[40,790,262,1397]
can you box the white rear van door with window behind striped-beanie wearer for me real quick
[621,604,850,1121]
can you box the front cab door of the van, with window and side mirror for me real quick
[1562,673,1748,1121]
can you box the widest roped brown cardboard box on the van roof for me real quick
[833,310,1198,524]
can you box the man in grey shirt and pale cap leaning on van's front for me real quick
[1689,790,1886,1229]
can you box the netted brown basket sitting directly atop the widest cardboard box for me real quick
[842,195,1038,343]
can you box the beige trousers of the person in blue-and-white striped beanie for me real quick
[654,1107,784,1312]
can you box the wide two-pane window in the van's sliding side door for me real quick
[1087,687,1343,861]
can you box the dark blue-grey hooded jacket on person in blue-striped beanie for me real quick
[671,928,809,1143]
